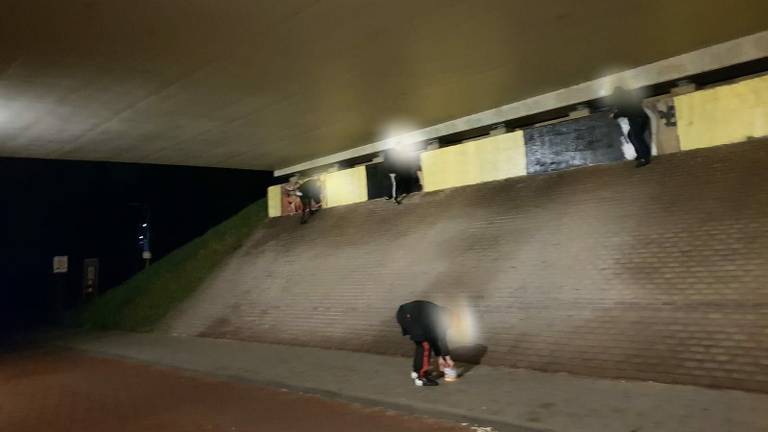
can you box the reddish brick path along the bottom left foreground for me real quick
[0,350,470,432]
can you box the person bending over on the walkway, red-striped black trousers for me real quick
[397,300,454,386]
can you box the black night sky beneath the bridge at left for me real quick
[0,158,273,331]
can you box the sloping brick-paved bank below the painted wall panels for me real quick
[167,141,768,391]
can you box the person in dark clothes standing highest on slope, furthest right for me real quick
[610,87,651,168]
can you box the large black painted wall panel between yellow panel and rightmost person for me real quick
[524,113,624,174]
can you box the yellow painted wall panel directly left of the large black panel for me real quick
[421,131,526,191]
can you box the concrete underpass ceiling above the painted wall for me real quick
[0,0,768,170]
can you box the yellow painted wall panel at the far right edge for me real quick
[675,75,768,150]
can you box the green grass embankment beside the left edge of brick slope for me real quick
[76,199,267,331]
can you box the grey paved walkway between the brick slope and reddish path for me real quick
[61,333,768,432]
